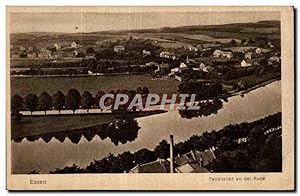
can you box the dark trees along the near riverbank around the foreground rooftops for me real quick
[50,113,282,173]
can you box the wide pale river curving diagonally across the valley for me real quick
[12,81,281,173]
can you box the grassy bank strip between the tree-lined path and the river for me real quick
[11,110,164,139]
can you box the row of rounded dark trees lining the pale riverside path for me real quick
[11,87,149,116]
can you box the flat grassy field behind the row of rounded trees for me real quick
[11,75,179,96]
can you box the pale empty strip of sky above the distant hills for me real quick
[10,12,280,33]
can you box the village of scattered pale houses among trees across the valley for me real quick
[10,26,281,93]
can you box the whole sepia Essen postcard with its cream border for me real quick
[6,7,294,190]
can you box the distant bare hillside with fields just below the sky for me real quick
[11,21,280,46]
